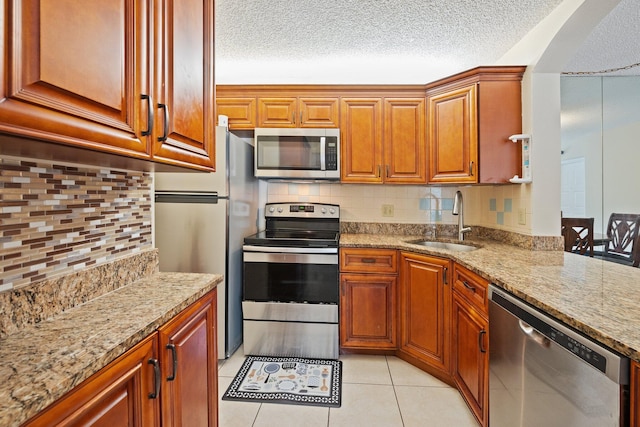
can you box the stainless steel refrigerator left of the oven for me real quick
[154,126,261,358]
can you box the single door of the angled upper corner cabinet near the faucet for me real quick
[427,84,478,183]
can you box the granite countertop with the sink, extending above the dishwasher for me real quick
[340,234,640,362]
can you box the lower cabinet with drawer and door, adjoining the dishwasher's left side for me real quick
[451,264,489,426]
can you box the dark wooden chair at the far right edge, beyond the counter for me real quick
[603,213,640,267]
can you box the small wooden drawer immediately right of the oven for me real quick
[340,248,398,274]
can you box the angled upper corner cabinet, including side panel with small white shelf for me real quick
[427,67,525,184]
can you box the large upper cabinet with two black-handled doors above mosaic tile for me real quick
[0,0,214,169]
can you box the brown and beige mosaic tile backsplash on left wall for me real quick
[0,158,152,292]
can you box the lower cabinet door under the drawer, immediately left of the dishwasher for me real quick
[452,291,489,426]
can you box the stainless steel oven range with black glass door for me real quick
[242,203,340,359]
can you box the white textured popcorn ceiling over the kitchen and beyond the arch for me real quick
[216,0,640,84]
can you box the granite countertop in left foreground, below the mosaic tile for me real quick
[0,273,222,426]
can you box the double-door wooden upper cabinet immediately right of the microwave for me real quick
[340,97,427,184]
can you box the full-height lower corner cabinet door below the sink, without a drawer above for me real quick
[399,253,451,374]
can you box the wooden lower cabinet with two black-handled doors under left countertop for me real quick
[24,289,218,427]
